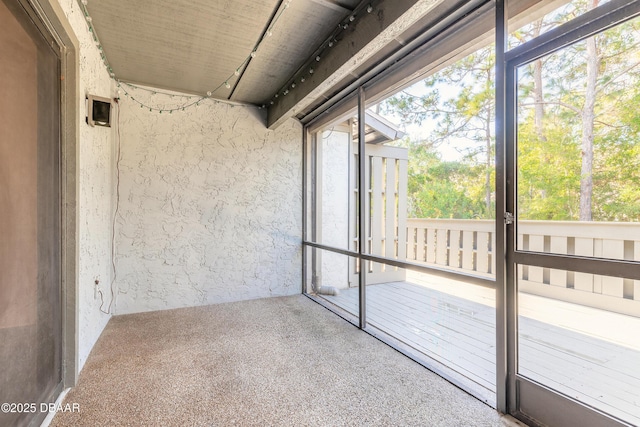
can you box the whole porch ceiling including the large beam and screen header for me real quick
[85,0,566,129]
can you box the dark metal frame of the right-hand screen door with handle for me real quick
[496,0,640,426]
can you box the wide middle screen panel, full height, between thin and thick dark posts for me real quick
[361,45,496,406]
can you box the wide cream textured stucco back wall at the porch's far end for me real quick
[116,88,302,314]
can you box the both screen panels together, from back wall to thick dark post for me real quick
[304,45,496,406]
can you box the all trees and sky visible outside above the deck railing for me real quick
[381,0,640,221]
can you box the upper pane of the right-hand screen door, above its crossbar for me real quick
[517,15,640,254]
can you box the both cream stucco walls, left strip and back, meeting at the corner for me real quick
[54,0,302,370]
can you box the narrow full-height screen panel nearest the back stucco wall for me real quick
[305,111,360,324]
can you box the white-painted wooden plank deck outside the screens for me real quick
[323,272,640,425]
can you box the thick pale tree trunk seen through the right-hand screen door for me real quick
[580,0,600,221]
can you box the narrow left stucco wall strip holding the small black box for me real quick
[60,0,115,370]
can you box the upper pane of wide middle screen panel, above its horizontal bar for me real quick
[364,45,495,283]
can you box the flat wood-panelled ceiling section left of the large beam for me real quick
[86,0,360,105]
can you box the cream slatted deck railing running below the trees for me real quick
[407,219,640,316]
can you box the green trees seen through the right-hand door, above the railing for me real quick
[518,4,640,221]
